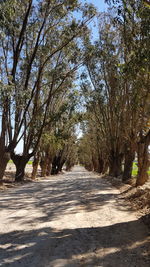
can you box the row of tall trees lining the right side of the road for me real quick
[79,0,150,185]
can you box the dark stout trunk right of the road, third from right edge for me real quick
[109,152,123,177]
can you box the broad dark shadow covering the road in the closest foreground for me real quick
[0,220,150,267]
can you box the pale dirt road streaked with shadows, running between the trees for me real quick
[0,167,150,267]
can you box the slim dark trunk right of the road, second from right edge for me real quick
[122,147,135,182]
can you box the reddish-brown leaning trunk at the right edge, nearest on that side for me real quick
[136,131,150,186]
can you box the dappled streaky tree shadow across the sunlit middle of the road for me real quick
[0,172,120,224]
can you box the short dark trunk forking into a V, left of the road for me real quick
[11,153,30,182]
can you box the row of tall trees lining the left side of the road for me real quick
[0,0,95,181]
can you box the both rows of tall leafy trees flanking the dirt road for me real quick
[0,0,150,185]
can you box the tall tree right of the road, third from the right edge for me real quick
[82,14,124,176]
